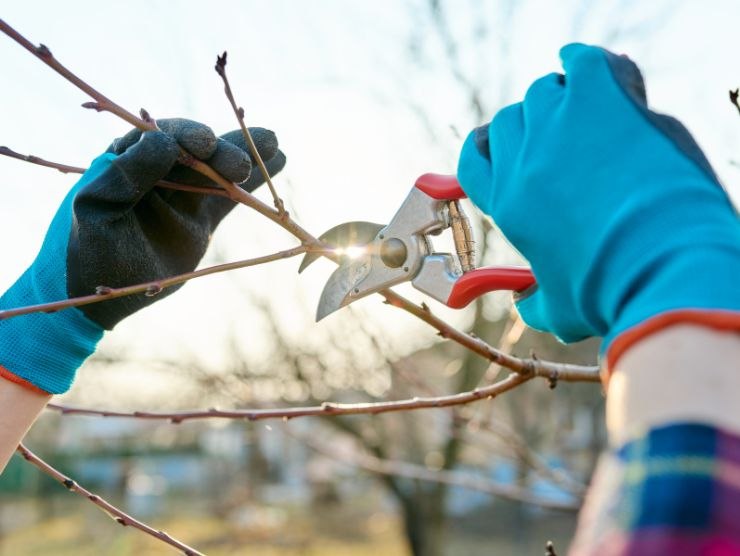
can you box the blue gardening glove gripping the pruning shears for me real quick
[458,44,740,360]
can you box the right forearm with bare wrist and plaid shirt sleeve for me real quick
[570,325,740,556]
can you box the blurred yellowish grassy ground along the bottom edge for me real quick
[0,496,572,556]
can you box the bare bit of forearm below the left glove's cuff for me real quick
[0,378,51,473]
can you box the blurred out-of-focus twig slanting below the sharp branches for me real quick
[292,429,580,512]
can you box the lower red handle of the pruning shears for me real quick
[447,266,535,309]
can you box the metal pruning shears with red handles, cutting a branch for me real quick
[298,174,535,321]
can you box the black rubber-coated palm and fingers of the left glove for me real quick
[67,119,285,330]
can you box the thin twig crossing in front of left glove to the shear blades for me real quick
[0,245,307,321]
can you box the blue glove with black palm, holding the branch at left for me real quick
[0,119,285,393]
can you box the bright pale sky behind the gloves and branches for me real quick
[0,0,740,402]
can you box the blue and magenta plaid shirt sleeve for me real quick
[570,423,740,556]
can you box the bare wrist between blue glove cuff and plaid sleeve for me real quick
[606,324,740,446]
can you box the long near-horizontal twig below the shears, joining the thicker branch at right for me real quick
[46,373,532,423]
